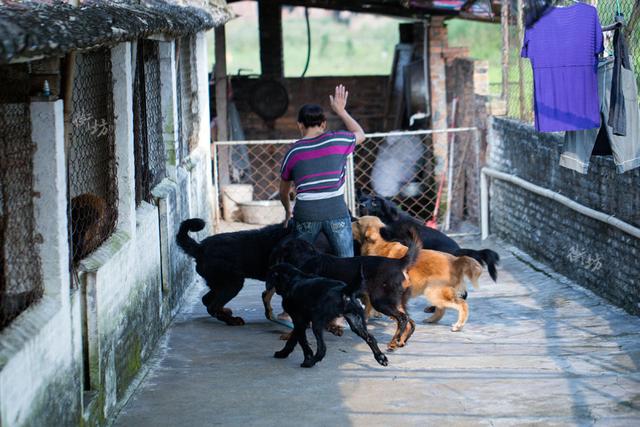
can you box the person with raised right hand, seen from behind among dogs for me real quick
[280,85,365,257]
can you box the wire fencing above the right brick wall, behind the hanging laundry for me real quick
[502,0,640,123]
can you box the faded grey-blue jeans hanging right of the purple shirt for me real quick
[560,58,640,174]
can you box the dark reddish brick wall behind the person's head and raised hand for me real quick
[232,76,388,139]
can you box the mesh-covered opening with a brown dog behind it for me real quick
[68,48,118,263]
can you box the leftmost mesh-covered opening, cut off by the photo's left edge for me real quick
[0,66,43,330]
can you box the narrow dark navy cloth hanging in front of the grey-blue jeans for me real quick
[607,14,631,136]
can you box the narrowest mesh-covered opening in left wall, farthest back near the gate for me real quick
[175,36,198,161]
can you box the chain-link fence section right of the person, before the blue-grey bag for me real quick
[354,128,480,230]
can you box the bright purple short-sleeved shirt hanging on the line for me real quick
[521,3,603,132]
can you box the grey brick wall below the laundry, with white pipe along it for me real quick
[489,117,640,314]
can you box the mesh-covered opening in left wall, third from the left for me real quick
[133,40,166,205]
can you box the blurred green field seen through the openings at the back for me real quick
[209,8,501,84]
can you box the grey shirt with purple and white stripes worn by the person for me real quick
[280,131,356,221]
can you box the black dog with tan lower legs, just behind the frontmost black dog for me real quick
[262,236,422,350]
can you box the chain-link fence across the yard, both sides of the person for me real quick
[214,128,480,231]
